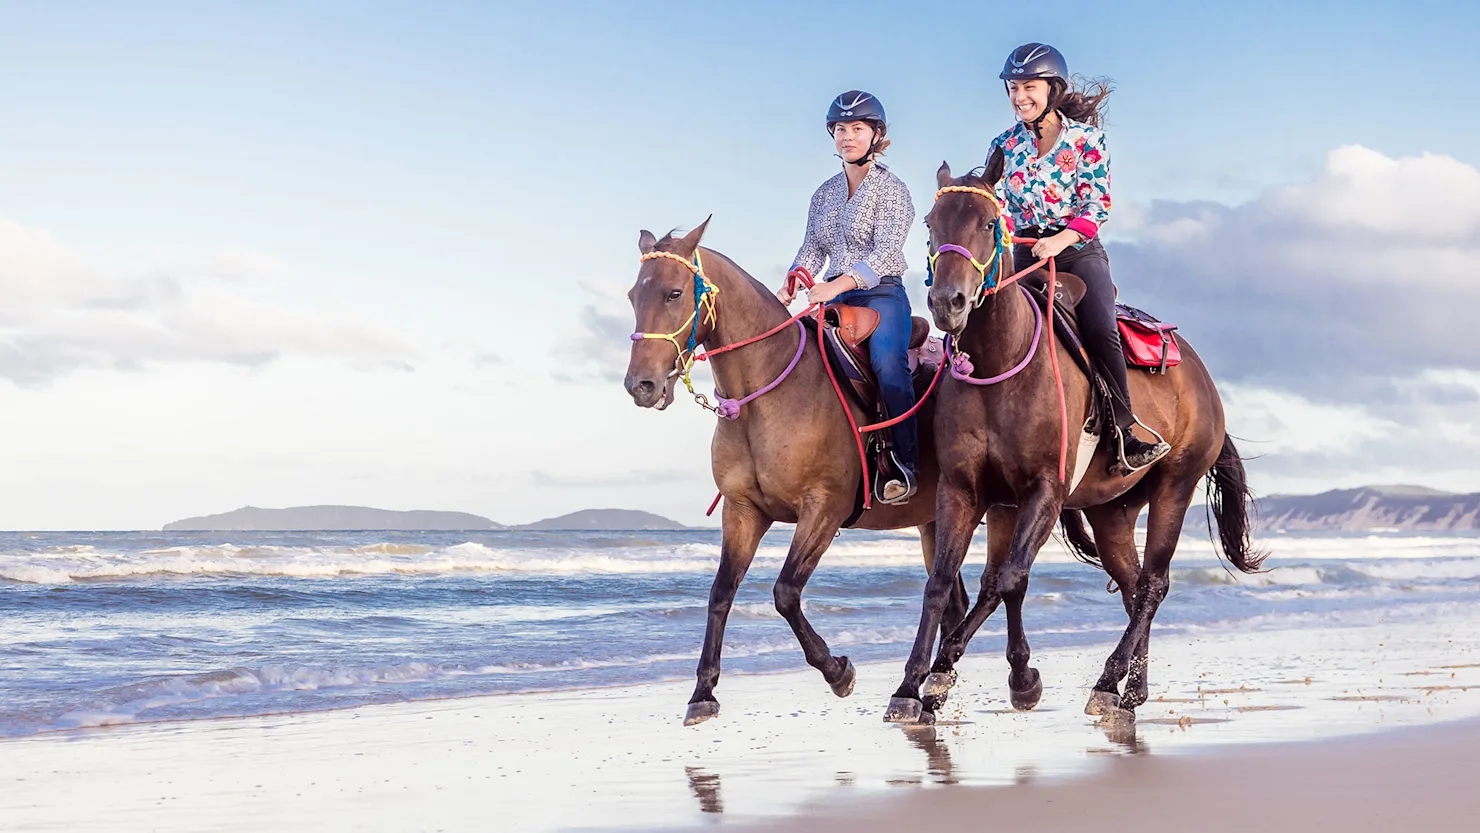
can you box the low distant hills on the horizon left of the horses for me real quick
[164,506,688,533]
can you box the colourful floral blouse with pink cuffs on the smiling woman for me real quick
[987,112,1110,240]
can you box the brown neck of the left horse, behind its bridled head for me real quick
[703,249,796,397]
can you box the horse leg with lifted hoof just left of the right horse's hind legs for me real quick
[998,479,1064,712]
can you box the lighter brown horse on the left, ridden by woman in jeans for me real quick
[626,220,968,725]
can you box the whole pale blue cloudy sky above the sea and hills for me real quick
[0,0,1480,530]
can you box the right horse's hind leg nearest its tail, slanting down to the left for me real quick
[1085,476,1197,721]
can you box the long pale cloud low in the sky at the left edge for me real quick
[0,214,414,386]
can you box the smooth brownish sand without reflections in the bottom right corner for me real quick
[736,721,1480,833]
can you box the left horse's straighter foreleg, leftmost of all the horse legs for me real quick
[684,497,771,726]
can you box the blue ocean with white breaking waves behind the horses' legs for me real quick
[0,527,1480,737]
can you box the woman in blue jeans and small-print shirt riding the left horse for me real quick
[777,90,919,503]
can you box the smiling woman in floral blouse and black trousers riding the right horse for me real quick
[987,43,1172,472]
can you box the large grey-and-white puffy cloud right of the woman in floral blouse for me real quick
[1110,146,1480,390]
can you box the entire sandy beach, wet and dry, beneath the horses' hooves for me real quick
[0,605,1480,832]
